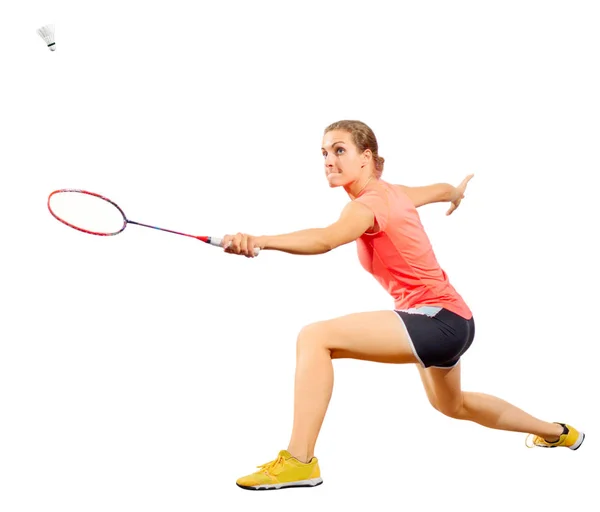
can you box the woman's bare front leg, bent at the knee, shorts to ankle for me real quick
[288,311,417,462]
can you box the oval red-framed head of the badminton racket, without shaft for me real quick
[48,188,128,236]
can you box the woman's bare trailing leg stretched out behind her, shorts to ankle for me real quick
[418,362,563,441]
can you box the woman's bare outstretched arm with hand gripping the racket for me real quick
[223,201,375,258]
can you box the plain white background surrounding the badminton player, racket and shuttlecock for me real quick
[0,0,600,512]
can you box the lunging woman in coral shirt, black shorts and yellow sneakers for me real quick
[223,121,585,490]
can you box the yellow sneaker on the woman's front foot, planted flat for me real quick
[236,450,323,491]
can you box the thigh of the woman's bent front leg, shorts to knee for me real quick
[308,310,417,363]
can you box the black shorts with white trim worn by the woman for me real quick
[395,306,475,368]
